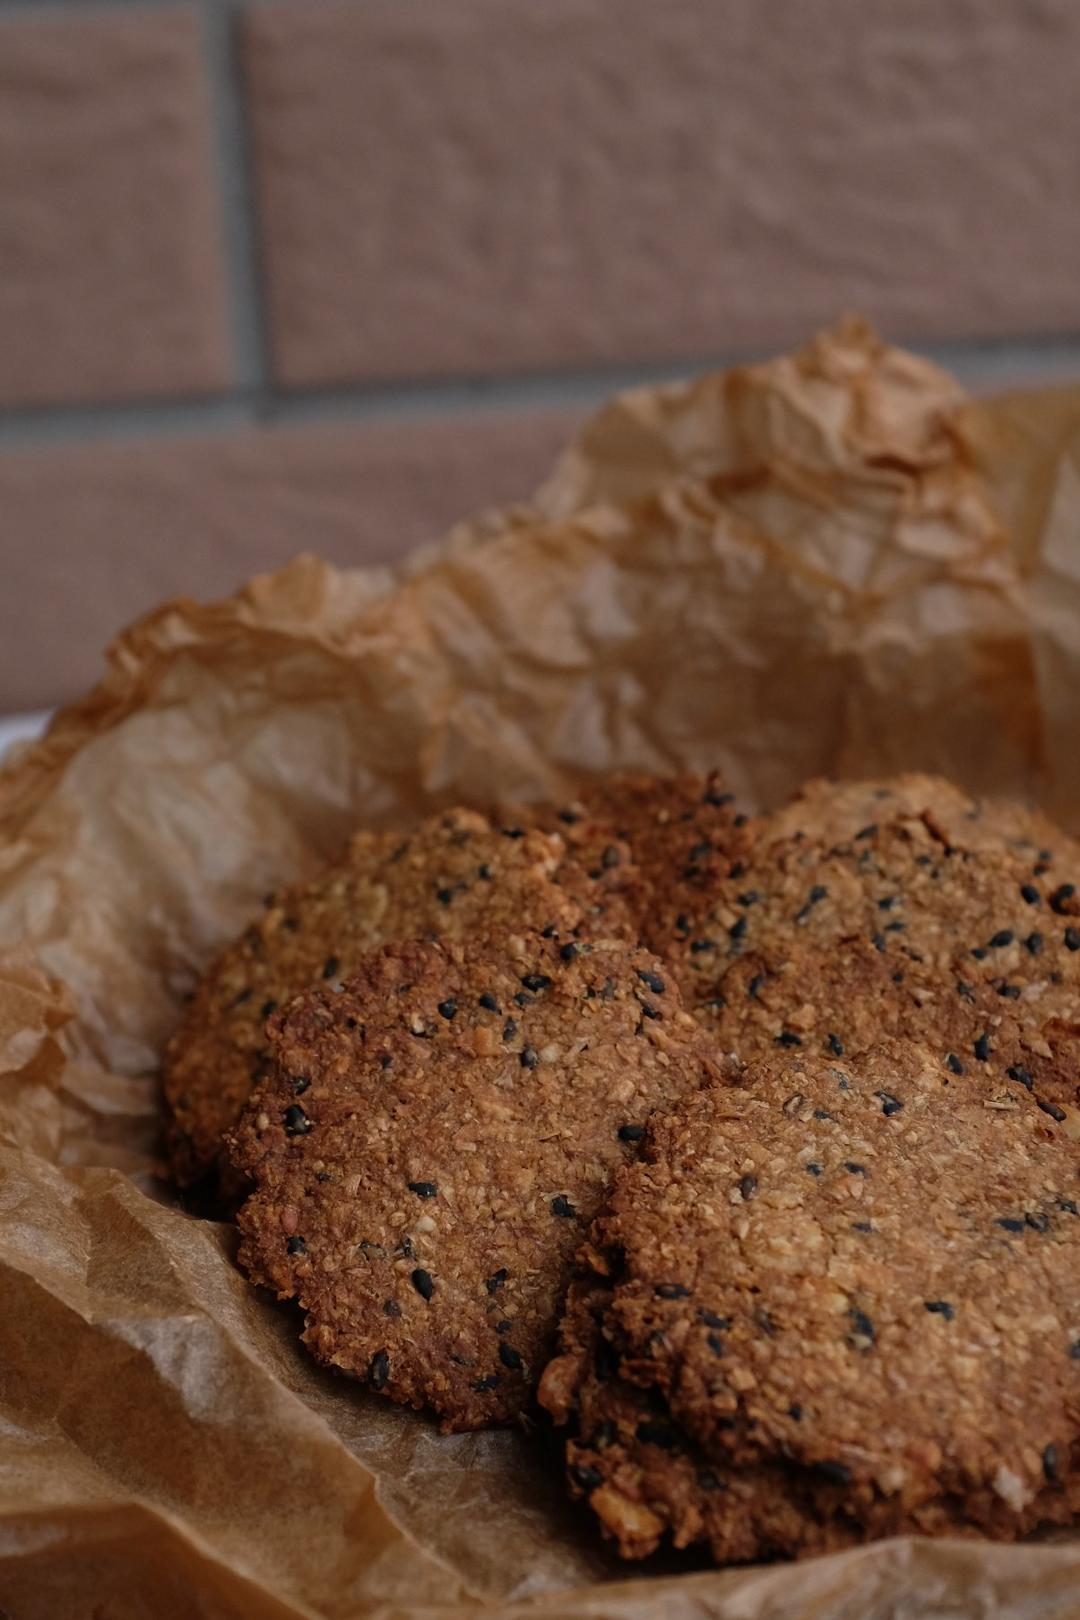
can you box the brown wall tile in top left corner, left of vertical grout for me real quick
[0,6,230,407]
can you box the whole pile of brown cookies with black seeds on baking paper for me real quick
[165,776,1080,1562]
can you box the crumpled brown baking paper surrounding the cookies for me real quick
[0,322,1080,1620]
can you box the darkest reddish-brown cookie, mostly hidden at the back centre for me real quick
[513,771,755,956]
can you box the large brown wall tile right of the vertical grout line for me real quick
[246,0,1080,387]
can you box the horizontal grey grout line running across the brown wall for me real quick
[0,332,1080,450]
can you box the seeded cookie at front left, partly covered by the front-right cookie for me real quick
[232,932,716,1429]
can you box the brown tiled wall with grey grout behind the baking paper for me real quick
[0,0,1080,710]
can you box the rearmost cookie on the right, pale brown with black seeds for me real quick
[674,779,1080,1022]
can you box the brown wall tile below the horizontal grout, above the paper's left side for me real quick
[0,411,580,713]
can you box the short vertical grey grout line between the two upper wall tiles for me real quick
[202,0,267,394]
